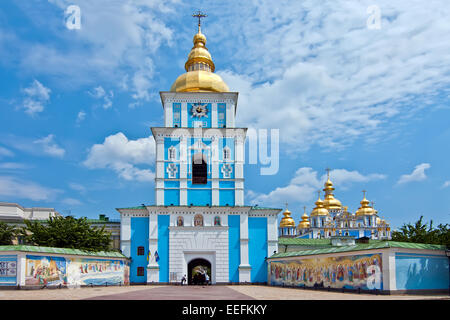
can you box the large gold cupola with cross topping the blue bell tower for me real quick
[170,12,230,92]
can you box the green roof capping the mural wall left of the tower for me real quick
[0,245,126,258]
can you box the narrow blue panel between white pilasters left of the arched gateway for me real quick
[159,215,170,282]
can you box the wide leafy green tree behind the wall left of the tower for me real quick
[22,216,111,251]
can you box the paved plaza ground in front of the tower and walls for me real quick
[0,285,450,300]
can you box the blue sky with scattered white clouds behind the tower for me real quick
[0,0,450,228]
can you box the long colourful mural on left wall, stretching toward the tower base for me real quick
[25,255,129,286]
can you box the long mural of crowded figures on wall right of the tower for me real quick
[270,254,383,290]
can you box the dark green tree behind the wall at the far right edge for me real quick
[392,216,450,248]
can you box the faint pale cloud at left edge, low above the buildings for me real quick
[0,176,62,201]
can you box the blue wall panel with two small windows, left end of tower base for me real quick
[130,217,149,283]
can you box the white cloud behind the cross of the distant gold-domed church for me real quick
[246,167,386,206]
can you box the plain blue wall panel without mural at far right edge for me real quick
[395,253,449,290]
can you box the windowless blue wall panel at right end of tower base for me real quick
[248,217,267,282]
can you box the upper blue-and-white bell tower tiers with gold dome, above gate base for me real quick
[152,12,247,206]
